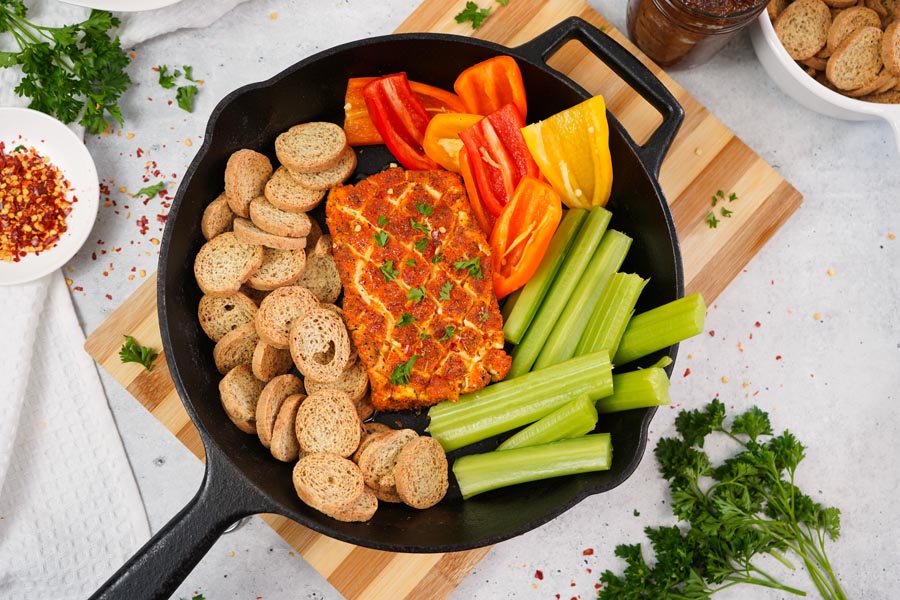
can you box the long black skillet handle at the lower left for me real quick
[91,451,267,600]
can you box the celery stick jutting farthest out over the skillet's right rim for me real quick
[616,294,706,366]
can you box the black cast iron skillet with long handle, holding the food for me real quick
[93,18,684,600]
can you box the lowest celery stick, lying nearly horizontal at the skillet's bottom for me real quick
[453,433,612,499]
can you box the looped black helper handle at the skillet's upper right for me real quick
[514,17,684,177]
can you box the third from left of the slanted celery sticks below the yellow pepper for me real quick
[533,229,631,369]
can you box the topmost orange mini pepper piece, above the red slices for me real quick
[453,55,528,120]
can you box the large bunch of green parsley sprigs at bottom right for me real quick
[599,400,847,600]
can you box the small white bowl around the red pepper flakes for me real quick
[0,108,100,285]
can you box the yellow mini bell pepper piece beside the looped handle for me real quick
[522,96,613,209]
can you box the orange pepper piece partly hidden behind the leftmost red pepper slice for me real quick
[344,77,466,146]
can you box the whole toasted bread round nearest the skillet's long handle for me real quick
[293,453,365,514]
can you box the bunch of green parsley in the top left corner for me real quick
[0,0,131,133]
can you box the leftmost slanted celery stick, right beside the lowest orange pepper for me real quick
[503,208,587,344]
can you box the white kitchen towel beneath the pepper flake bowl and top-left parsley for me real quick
[0,0,250,600]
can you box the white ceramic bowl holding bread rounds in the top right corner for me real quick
[750,11,900,152]
